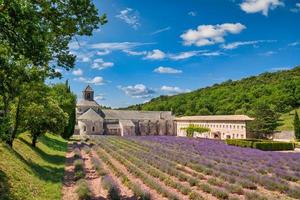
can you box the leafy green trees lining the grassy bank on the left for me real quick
[0,0,107,146]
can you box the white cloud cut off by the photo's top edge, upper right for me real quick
[240,0,284,16]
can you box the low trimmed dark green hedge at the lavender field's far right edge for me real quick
[226,139,295,151]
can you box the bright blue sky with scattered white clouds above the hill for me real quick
[54,0,300,108]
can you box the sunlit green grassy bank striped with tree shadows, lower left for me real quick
[0,134,67,200]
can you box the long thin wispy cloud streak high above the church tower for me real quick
[90,42,153,51]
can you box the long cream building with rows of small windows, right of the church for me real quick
[175,115,253,140]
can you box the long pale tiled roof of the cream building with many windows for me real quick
[175,115,254,121]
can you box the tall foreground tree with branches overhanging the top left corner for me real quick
[0,0,107,146]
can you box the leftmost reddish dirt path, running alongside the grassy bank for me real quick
[62,143,78,200]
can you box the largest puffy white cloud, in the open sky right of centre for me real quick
[180,23,246,46]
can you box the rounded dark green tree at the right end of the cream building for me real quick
[248,101,278,138]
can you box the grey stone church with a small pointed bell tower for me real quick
[75,85,176,136]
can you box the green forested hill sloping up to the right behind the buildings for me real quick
[126,66,300,116]
